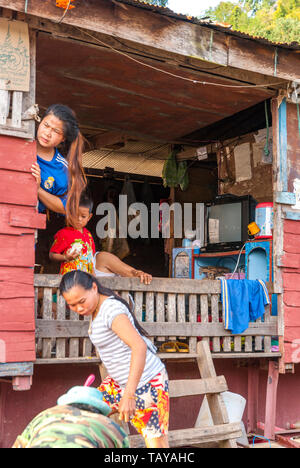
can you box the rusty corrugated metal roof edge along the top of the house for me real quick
[113,0,300,50]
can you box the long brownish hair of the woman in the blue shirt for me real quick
[43,104,87,225]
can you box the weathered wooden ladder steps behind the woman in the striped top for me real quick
[101,341,242,448]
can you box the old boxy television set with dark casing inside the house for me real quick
[204,194,257,251]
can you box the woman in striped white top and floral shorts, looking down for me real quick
[60,270,169,448]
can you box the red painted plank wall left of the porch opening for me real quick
[0,136,45,362]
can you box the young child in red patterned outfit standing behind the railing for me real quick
[49,194,95,275]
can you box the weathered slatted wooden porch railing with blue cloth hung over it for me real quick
[35,275,280,364]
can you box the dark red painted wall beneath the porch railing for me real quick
[0,359,300,448]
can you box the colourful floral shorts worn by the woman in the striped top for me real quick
[98,370,169,439]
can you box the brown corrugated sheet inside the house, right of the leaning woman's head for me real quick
[83,141,170,177]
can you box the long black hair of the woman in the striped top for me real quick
[59,270,148,336]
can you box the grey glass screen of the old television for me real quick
[208,203,243,244]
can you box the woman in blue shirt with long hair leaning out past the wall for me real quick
[32,104,86,227]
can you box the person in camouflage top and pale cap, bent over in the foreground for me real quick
[12,387,129,449]
